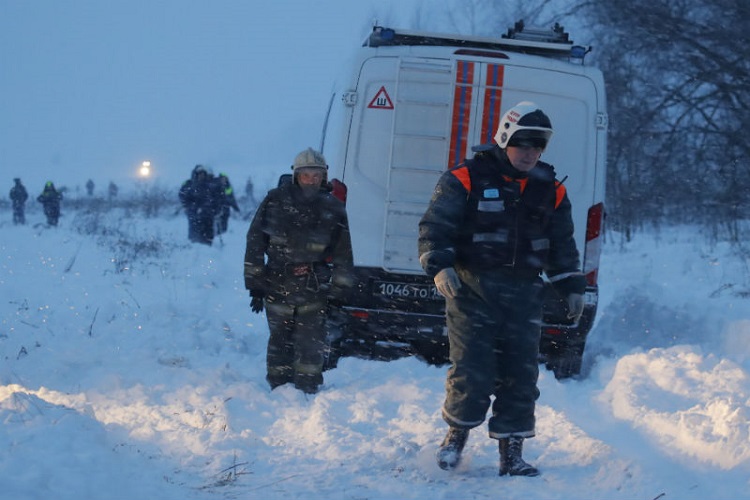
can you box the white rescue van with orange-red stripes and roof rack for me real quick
[321,22,607,378]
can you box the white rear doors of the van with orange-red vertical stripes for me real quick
[350,56,605,273]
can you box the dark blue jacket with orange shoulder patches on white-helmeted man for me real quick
[419,147,585,293]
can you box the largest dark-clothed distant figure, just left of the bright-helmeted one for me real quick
[179,165,223,245]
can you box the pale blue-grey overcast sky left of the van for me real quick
[0,0,419,193]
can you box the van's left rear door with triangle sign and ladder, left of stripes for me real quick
[343,57,453,274]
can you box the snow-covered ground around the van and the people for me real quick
[0,205,750,500]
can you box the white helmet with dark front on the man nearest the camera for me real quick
[495,101,552,149]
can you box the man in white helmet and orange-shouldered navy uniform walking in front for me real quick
[419,101,586,476]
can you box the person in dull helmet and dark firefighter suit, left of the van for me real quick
[244,148,353,394]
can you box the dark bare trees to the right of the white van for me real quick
[580,0,750,238]
